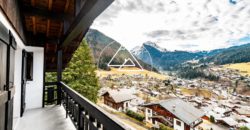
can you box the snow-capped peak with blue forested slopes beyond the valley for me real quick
[131,41,207,70]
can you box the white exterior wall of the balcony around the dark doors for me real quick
[0,11,44,128]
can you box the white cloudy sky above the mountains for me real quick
[92,0,250,50]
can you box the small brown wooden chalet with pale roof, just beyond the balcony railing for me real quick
[102,90,136,111]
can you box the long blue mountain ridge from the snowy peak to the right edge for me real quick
[131,43,250,70]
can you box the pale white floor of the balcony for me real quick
[16,105,75,130]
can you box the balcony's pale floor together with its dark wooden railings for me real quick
[24,82,129,130]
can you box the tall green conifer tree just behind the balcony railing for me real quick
[63,40,100,102]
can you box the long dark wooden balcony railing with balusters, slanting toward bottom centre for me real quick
[60,82,128,130]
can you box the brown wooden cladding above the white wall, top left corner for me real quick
[0,0,24,40]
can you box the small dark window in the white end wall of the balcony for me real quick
[26,52,33,81]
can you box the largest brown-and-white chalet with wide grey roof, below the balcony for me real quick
[143,98,205,130]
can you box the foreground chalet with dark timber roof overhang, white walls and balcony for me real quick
[0,0,129,130]
